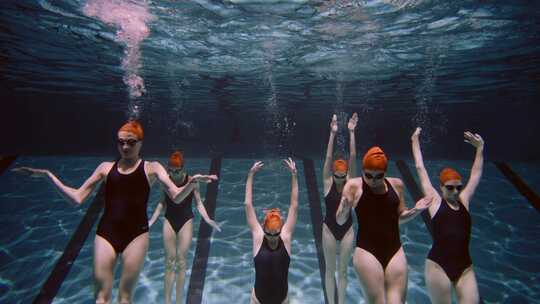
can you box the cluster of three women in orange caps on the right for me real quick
[322,113,484,304]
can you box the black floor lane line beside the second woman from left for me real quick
[186,156,221,304]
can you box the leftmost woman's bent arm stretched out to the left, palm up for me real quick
[12,162,112,205]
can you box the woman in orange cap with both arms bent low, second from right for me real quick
[336,147,431,304]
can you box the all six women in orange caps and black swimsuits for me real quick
[14,113,484,304]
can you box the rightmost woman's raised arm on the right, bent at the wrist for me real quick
[459,131,484,208]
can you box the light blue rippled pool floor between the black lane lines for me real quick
[0,157,540,303]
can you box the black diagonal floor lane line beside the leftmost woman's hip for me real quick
[33,184,105,304]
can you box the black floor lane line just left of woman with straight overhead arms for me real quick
[302,158,337,304]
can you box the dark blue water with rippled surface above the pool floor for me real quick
[0,0,540,160]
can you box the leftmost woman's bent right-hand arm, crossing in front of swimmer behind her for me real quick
[149,162,218,204]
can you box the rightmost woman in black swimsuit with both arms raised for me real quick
[411,128,484,304]
